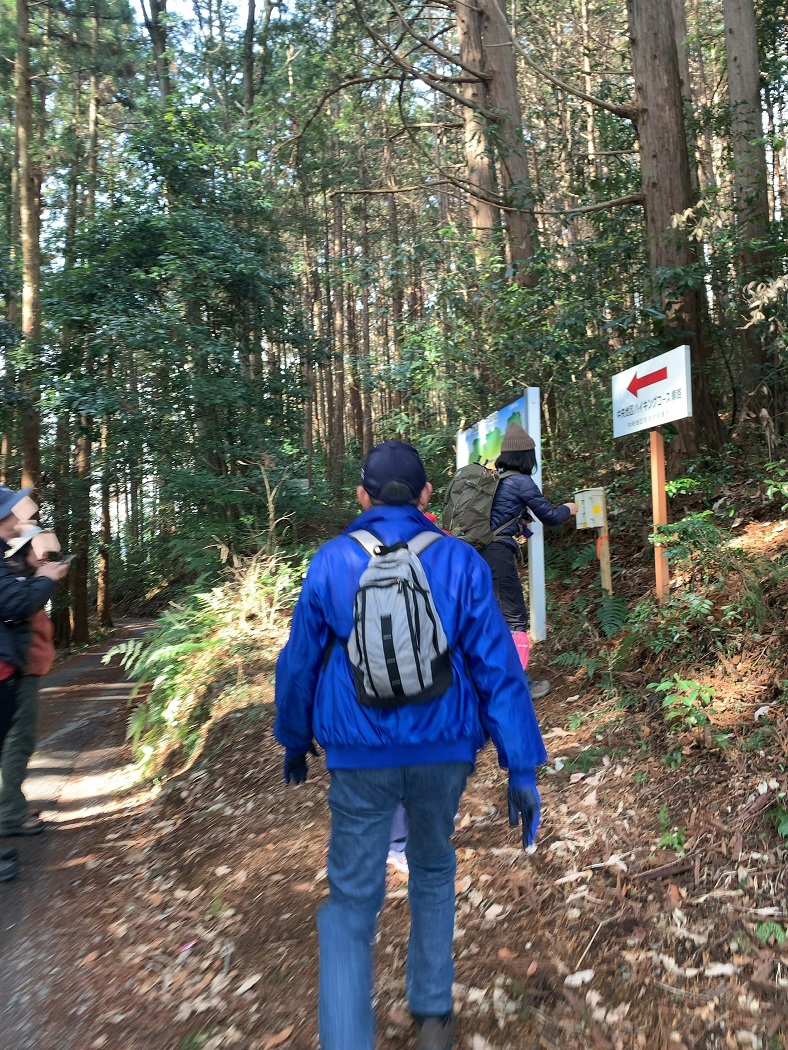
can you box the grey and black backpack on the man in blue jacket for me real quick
[347,529,453,708]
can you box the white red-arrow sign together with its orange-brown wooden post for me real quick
[613,345,692,603]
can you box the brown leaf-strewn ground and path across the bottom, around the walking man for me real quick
[0,522,788,1050]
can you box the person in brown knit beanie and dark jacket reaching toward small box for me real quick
[479,423,578,700]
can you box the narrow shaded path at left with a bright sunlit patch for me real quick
[0,621,149,1050]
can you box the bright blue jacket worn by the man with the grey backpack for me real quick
[274,506,546,783]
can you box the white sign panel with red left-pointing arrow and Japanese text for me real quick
[613,347,692,438]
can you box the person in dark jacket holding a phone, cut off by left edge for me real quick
[0,485,68,882]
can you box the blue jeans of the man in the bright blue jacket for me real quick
[317,762,473,1050]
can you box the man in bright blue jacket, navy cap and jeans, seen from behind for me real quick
[274,441,546,1050]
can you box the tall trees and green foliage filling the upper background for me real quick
[0,0,788,641]
